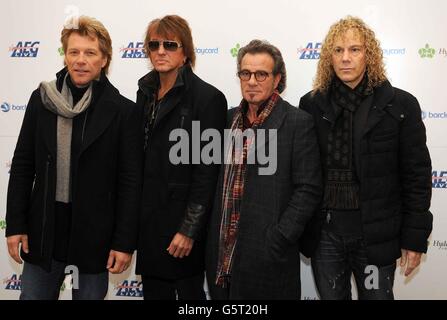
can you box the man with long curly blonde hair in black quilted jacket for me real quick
[300,17,433,299]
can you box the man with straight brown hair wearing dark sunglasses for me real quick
[137,15,227,299]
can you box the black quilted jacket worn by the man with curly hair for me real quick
[300,81,433,266]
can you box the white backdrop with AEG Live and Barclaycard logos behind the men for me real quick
[0,0,447,299]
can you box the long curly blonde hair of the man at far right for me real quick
[313,16,386,93]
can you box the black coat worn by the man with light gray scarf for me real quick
[6,68,142,273]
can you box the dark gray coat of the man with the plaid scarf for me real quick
[206,99,322,299]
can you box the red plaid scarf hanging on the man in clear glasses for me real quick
[216,91,279,288]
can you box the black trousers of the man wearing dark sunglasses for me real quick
[141,273,206,300]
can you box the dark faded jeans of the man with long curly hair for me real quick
[311,228,396,300]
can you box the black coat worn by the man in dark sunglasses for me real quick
[136,66,227,279]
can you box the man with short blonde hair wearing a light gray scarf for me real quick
[6,16,142,300]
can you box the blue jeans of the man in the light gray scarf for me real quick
[20,260,109,300]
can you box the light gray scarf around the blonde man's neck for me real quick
[39,73,92,203]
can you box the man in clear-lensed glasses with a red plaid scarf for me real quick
[206,40,322,299]
